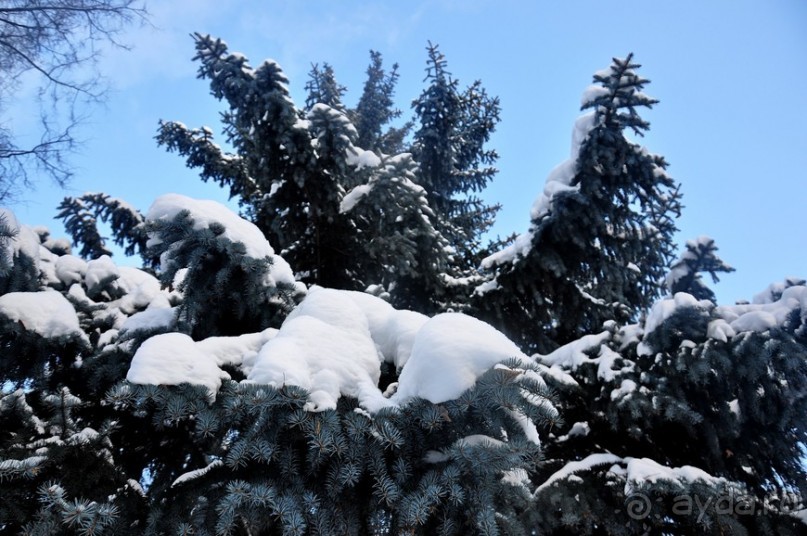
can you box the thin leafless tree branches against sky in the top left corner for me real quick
[0,0,147,203]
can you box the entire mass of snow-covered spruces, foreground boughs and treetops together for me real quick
[0,47,807,536]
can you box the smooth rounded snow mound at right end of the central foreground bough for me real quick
[393,313,530,404]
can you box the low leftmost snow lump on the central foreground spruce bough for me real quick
[126,333,229,399]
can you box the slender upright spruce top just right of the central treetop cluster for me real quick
[412,43,499,301]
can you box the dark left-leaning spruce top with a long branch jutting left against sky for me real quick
[157,35,386,294]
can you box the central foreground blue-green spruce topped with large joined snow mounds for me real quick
[118,282,557,534]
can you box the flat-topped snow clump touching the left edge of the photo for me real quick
[0,290,89,343]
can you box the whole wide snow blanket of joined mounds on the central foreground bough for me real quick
[125,287,543,412]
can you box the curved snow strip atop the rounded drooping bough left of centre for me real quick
[146,194,295,285]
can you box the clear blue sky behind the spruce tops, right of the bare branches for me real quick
[15,0,807,303]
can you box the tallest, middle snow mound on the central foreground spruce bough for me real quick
[247,287,428,412]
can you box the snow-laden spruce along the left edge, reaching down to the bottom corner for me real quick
[0,212,180,535]
